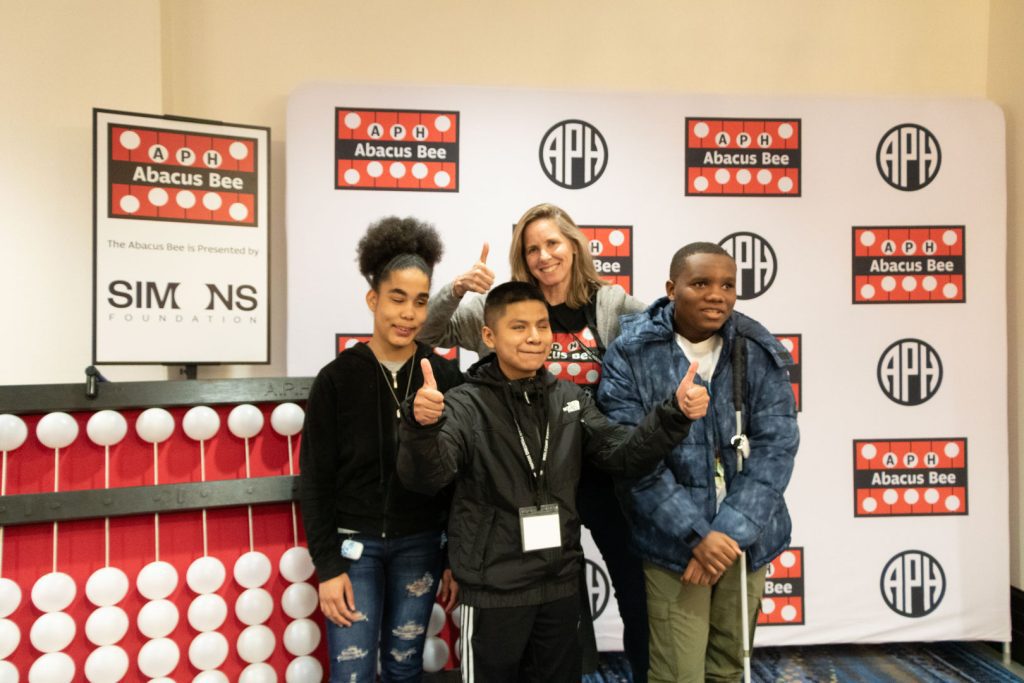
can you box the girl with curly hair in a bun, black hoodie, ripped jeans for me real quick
[300,217,461,682]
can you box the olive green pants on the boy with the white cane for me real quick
[644,561,768,683]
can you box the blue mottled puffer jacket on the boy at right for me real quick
[598,297,800,573]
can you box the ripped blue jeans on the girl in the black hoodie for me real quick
[327,531,442,683]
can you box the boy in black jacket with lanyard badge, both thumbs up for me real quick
[397,282,709,683]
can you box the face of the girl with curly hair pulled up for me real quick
[367,268,430,354]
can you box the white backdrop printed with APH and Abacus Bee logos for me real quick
[287,84,1010,649]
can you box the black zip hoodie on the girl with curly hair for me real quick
[299,343,462,581]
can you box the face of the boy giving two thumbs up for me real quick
[483,300,551,380]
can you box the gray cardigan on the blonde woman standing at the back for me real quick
[417,283,647,357]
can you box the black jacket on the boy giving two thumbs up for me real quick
[398,354,690,607]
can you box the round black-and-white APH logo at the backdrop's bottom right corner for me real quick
[879,550,946,618]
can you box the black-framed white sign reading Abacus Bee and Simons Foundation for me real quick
[92,109,270,365]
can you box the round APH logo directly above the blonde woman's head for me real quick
[541,119,608,189]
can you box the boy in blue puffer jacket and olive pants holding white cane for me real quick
[598,242,800,683]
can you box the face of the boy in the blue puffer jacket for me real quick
[666,254,736,342]
